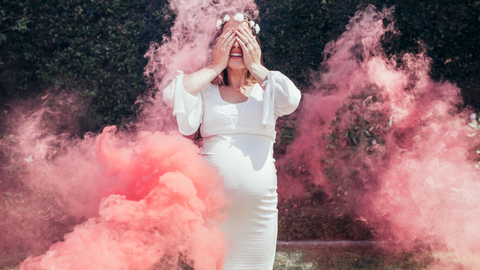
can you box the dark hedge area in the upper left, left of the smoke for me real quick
[0,0,170,124]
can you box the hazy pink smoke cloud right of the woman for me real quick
[278,6,480,253]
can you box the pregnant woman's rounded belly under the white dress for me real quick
[202,134,277,200]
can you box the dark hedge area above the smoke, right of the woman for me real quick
[258,0,480,108]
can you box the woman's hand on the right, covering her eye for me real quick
[235,26,262,71]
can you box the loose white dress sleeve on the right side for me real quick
[262,71,301,132]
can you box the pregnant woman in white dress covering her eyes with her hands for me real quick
[163,14,301,270]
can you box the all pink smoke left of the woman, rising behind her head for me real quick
[1,0,258,270]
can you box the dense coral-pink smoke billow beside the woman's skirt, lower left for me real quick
[20,127,228,270]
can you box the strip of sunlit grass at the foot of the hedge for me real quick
[0,247,480,270]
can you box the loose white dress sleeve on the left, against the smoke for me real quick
[163,70,203,135]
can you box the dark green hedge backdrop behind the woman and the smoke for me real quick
[0,0,480,247]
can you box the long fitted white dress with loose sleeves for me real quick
[163,71,301,270]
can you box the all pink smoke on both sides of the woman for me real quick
[0,0,480,270]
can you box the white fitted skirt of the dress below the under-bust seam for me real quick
[202,134,277,270]
